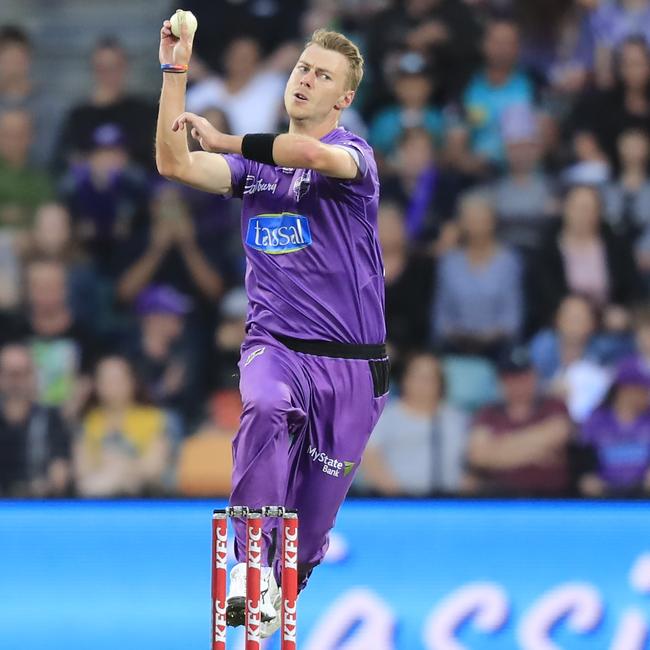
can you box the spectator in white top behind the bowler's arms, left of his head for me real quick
[186,36,297,134]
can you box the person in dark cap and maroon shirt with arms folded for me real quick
[465,347,572,496]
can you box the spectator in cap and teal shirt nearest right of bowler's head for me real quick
[369,52,443,156]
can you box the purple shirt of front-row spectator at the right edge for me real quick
[582,407,650,488]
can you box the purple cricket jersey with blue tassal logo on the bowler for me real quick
[224,127,386,343]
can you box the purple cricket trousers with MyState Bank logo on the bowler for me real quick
[230,324,389,589]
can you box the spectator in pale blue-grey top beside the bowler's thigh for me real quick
[361,353,468,496]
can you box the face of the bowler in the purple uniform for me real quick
[284,45,354,122]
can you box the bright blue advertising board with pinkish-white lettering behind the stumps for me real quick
[0,501,650,650]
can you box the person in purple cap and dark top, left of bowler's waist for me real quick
[126,285,199,422]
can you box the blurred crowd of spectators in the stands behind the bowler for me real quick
[0,0,650,497]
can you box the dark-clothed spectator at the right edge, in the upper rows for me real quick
[567,36,650,167]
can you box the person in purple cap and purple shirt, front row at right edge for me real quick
[579,358,650,497]
